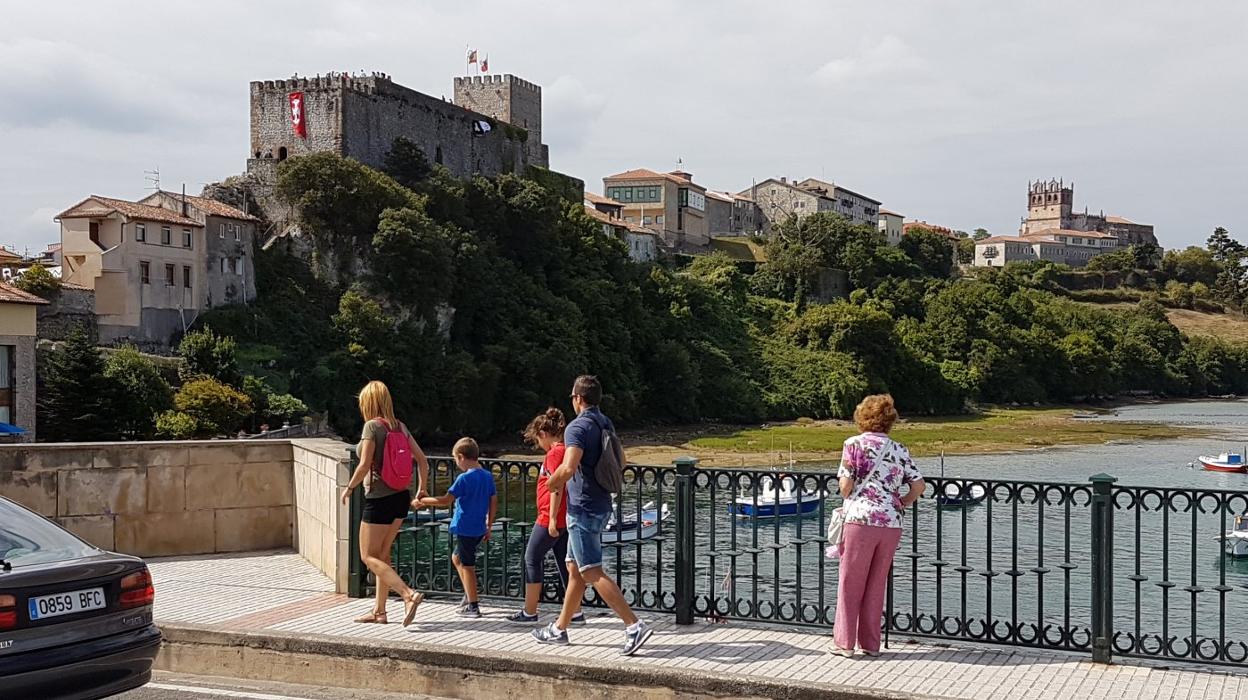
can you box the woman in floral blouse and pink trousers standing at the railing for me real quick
[832,394,925,656]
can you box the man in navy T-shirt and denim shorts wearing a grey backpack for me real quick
[533,374,654,656]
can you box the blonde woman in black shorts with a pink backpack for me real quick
[342,381,429,626]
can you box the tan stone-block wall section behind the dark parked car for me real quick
[0,440,295,557]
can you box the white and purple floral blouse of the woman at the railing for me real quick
[836,433,924,528]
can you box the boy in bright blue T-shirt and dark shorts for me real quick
[413,438,498,618]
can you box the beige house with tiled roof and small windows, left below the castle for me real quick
[55,192,256,351]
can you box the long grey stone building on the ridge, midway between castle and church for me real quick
[740,177,880,231]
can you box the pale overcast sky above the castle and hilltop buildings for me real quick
[0,0,1248,251]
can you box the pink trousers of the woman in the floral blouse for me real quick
[832,523,901,651]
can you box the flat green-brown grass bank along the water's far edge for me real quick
[688,408,1193,459]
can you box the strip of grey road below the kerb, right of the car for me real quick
[116,673,447,700]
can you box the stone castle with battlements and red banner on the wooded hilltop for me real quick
[247,72,549,221]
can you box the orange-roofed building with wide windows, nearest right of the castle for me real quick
[603,168,710,252]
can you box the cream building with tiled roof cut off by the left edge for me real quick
[0,282,47,442]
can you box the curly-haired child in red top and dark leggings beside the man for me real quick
[507,408,585,624]
